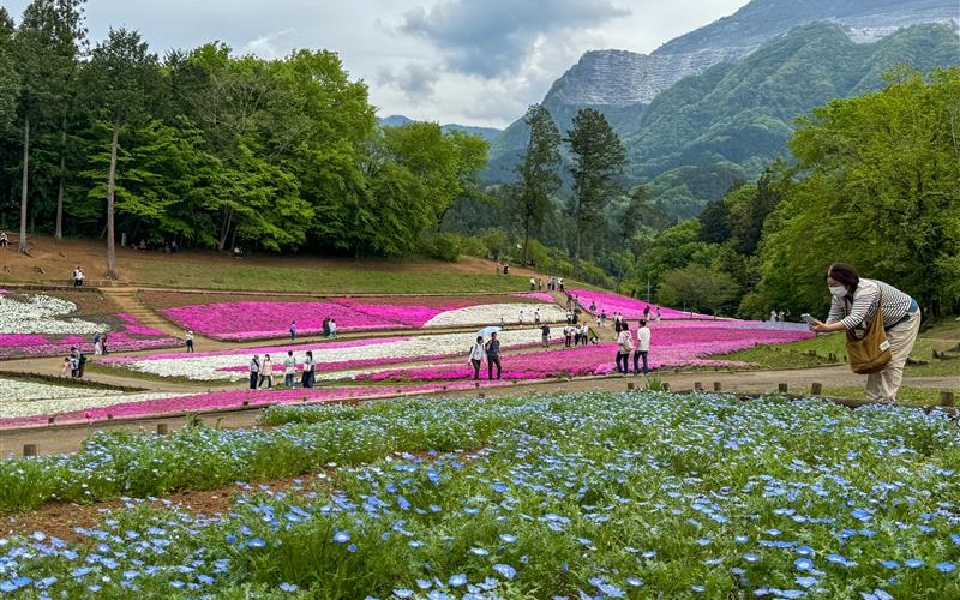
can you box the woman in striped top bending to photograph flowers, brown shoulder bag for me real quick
[810,263,920,402]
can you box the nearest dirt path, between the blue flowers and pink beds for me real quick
[0,366,960,456]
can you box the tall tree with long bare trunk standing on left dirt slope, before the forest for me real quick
[86,29,160,279]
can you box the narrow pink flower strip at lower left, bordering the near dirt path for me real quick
[0,382,507,429]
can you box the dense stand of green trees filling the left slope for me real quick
[0,0,487,270]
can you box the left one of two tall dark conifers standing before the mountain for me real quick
[513,104,563,265]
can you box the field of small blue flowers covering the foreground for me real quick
[0,393,960,600]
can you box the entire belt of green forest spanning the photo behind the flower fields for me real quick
[0,0,960,317]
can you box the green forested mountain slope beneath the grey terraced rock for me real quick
[624,23,960,217]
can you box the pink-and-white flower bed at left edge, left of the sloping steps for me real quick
[0,292,178,358]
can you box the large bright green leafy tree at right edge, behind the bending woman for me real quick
[760,68,960,314]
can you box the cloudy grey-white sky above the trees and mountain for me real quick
[3,0,747,127]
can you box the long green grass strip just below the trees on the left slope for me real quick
[125,261,529,294]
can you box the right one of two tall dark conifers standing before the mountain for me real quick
[566,108,627,265]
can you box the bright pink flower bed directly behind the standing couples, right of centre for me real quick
[356,323,811,381]
